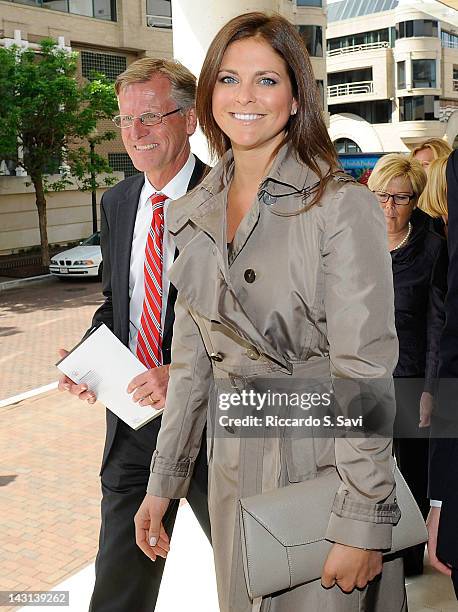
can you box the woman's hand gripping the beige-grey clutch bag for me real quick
[321,544,382,593]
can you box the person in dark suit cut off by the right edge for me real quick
[427,151,458,599]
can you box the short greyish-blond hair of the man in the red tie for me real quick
[115,57,196,109]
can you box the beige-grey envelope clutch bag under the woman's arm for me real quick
[239,468,428,599]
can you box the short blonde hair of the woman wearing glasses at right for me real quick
[367,153,426,198]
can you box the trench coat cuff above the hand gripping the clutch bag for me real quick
[326,513,393,550]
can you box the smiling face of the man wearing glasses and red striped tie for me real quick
[118,75,196,189]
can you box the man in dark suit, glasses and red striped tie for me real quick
[59,58,210,612]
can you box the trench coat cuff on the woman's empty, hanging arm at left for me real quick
[146,451,194,499]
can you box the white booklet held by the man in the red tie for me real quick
[56,324,162,429]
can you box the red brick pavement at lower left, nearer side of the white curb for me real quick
[0,391,105,611]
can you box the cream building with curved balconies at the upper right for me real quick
[326,0,458,153]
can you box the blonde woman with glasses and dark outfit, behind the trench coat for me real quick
[368,154,447,575]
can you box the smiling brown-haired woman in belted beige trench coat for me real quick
[136,13,406,612]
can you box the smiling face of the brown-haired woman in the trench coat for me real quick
[212,38,297,152]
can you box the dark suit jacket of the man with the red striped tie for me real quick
[92,157,207,471]
